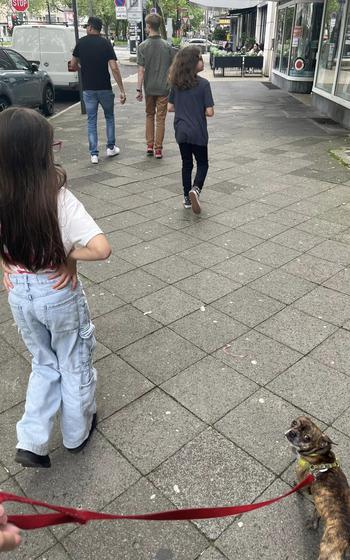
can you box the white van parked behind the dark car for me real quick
[12,24,86,90]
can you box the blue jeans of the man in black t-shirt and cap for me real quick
[83,89,115,156]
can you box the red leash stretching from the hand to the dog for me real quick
[0,474,315,530]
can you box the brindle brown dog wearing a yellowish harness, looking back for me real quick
[285,416,350,560]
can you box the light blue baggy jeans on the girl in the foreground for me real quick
[9,274,96,455]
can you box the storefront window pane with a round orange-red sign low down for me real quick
[289,3,323,78]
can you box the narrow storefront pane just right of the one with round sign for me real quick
[316,0,344,93]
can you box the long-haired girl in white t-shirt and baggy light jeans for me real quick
[0,108,110,468]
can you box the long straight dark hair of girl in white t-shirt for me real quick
[0,108,66,272]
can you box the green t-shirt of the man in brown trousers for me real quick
[137,35,173,95]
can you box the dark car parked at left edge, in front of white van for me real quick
[0,47,55,116]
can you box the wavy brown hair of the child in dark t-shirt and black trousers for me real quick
[169,46,201,89]
